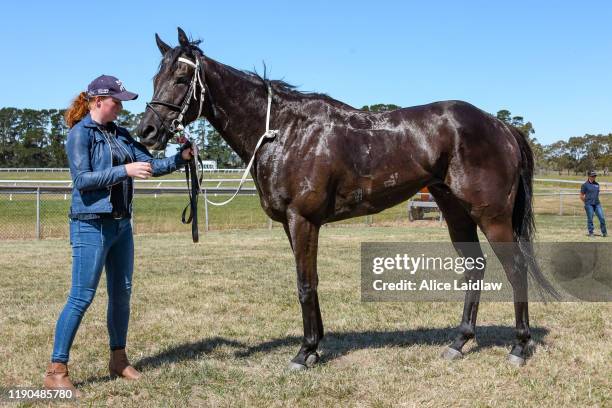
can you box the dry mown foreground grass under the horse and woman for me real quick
[0,215,612,407]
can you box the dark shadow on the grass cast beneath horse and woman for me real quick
[77,326,549,385]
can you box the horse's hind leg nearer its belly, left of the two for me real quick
[429,184,484,360]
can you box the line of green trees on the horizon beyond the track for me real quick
[0,104,612,174]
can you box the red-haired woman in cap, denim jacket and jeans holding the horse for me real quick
[44,75,192,393]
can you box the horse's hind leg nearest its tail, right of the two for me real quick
[482,217,531,366]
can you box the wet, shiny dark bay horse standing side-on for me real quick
[137,28,554,369]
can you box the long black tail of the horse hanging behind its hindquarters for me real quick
[512,127,559,299]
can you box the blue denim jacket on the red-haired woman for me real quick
[65,114,187,214]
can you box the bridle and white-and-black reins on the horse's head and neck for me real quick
[147,56,278,243]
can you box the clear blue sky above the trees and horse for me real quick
[0,0,612,143]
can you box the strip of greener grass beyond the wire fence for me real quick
[0,188,612,240]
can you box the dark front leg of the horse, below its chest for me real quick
[284,209,323,370]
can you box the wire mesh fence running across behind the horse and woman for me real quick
[0,185,612,240]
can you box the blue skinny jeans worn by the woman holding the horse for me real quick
[51,218,134,363]
